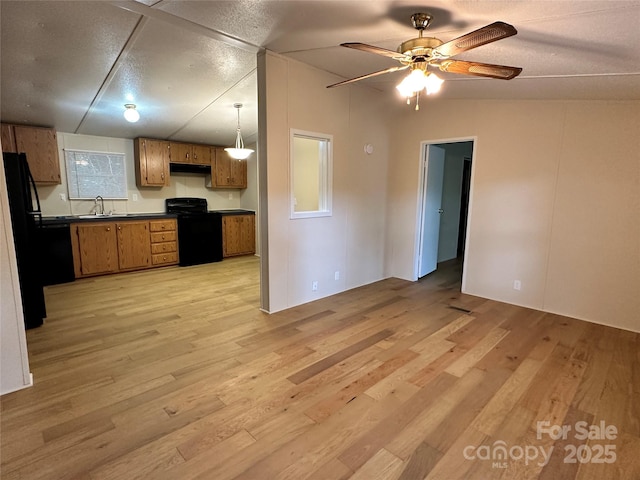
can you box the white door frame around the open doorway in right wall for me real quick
[412,136,478,292]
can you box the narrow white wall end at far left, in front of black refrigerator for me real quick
[0,144,32,395]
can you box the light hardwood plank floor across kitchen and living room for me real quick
[1,257,640,480]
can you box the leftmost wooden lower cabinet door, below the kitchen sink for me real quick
[75,222,118,275]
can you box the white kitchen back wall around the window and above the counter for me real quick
[38,132,257,216]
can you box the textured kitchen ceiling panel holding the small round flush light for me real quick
[78,15,256,141]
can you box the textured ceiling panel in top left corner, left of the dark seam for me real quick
[0,1,138,131]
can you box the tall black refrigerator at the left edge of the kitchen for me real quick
[2,153,47,328]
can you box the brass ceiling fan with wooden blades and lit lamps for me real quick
[327,13,522,110]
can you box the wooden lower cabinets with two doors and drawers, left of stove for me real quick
[71,218,178,278]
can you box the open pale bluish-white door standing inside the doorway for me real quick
[418,145,444,278]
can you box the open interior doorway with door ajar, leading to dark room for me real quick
[415,139,474,279]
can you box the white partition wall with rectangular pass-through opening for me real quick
[258,52,389,312]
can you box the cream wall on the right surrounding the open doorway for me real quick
[387,100,640,331]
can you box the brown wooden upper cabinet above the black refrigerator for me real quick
[2,123,61,185]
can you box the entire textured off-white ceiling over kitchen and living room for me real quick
[0,0,640,145]
